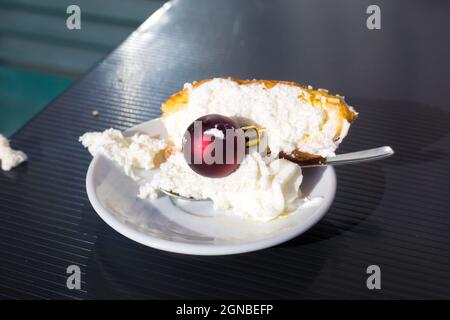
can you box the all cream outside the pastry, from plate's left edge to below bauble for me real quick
[79,129,308,221]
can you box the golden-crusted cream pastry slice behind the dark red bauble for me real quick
[161,78,357,163]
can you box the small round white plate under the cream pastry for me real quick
[86,119,336,255]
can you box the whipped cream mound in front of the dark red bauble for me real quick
[139,152,302,221]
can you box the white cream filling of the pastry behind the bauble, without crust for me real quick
[162,78,350,157]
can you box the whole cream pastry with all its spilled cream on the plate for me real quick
[80,78,357,221]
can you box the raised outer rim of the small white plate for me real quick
[86,118,337,256]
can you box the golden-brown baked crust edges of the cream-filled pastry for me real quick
[161,77,357,162]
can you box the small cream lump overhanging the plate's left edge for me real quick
[79,129,167,180]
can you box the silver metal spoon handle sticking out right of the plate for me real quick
[302,146,394,168]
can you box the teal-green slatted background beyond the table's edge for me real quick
[0,0,164,137]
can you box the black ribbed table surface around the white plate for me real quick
[0,0,450,299]
